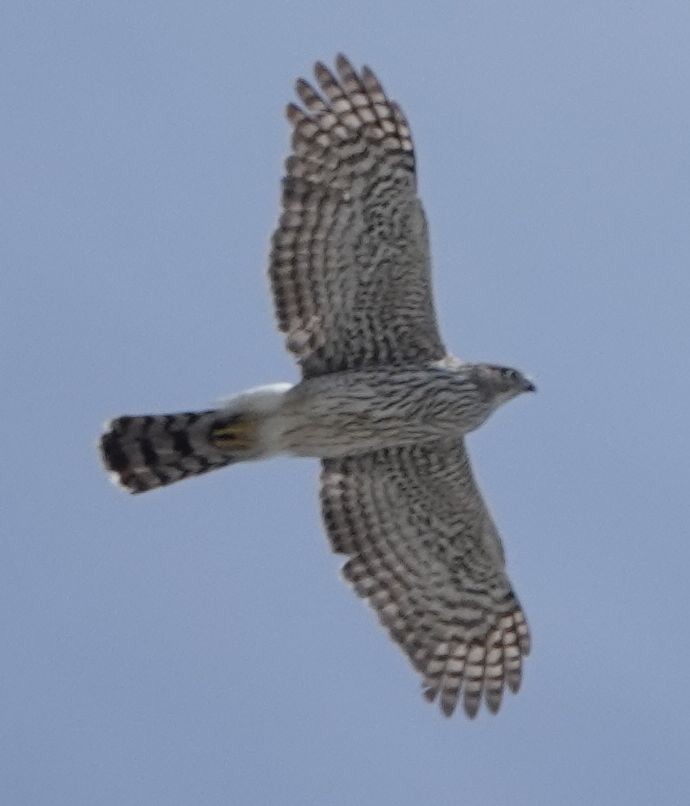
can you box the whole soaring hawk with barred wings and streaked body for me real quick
[100,55,534,717]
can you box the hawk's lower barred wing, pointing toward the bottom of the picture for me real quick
[321,441,529,716]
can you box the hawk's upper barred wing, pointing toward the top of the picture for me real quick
[270,56,445,376]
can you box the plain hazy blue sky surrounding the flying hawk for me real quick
[5,0,690,806]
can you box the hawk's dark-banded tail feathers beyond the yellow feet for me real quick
[100,409,235,493]
